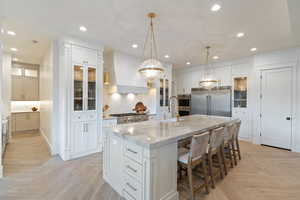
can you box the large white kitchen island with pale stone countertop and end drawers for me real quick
[103,115,234,200]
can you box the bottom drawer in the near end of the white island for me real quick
[123,174,142,200]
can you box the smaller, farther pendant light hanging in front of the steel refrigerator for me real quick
[199,46,218,90]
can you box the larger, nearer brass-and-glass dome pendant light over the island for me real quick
[138,13,165,81]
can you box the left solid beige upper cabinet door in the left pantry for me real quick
[11,76,25,101]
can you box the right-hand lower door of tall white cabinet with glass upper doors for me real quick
[84,121,99,151]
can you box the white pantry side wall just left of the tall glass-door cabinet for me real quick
[39,44,54,154]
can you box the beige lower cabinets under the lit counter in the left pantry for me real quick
[11,112,40,132]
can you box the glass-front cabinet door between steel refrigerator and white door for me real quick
[233,77,248,108]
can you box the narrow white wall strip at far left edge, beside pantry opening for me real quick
[1,54,12,117]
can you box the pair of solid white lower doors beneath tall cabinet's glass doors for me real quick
[71,121,99,158]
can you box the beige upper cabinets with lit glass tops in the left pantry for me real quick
[11,63,39,101]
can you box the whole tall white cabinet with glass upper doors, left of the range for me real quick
[61,42,103,160]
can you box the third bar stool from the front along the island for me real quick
[223,123,236,168]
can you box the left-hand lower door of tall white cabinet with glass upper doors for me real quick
[71,122,85,156]
